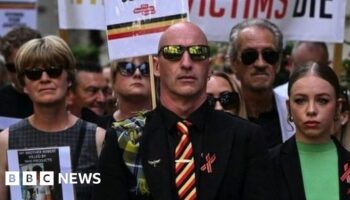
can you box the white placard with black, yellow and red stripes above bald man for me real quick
[105,0,188,60]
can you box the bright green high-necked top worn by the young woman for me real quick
[297,141,339,200]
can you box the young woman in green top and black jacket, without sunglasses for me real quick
[270,62,350,200]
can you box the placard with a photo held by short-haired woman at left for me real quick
[6,147,74,200]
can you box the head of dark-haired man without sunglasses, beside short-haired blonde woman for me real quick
[69,62,108,117]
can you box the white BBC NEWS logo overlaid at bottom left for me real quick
[5,171,101,186]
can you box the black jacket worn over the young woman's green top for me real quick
[270,136,350,200]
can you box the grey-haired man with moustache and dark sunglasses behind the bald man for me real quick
[229,19,293,148]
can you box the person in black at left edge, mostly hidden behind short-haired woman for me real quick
[0,27,41,118]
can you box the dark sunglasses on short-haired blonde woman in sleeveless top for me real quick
[23,66,63,81]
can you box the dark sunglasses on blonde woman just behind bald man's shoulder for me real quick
[207,91,239,110]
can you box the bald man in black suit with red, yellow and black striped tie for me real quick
[97,22,271,200]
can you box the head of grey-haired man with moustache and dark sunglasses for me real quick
[229,19,283,91]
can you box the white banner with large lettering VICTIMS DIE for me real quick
[189,0,346,42]
